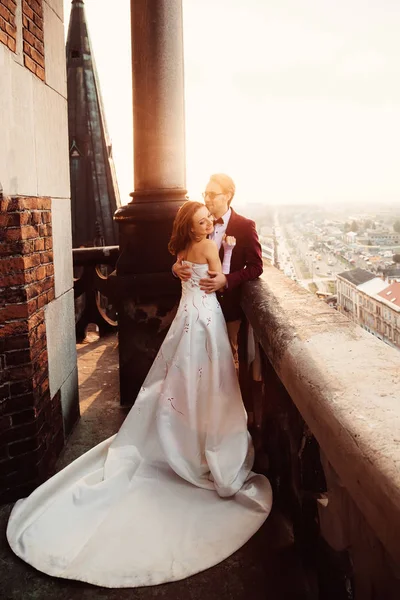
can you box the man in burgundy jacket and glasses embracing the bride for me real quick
[172,173,263,362]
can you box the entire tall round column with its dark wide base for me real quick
[115,0,186,404]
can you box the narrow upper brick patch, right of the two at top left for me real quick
[22,0,45,81]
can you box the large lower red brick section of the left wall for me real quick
[0,197,64,503]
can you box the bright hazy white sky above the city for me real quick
[65,0,400,206]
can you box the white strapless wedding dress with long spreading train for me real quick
[7,263,272,588]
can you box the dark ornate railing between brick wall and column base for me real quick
[72,246,119,342]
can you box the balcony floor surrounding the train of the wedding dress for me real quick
[0,334,317,600]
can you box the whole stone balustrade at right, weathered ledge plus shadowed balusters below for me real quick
[240,266,400,600]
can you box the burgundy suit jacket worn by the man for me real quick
[217,209,263,321]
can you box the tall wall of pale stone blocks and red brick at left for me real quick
[0,0,79,503]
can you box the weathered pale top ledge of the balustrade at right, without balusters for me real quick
[242,267,400,570]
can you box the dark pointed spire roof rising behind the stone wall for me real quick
[66,0,121,248]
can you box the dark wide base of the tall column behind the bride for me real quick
[115,190,187,405]
